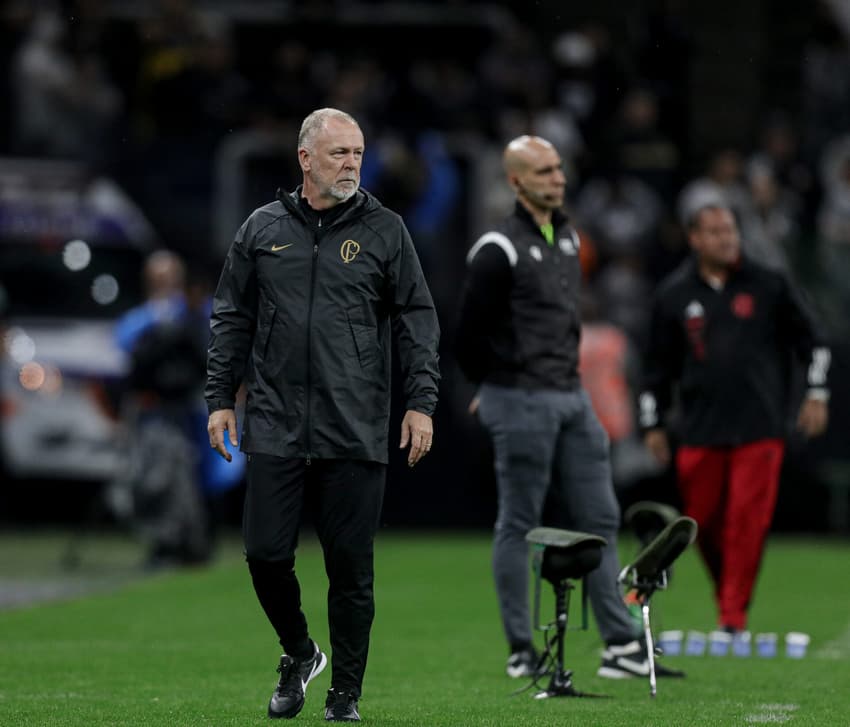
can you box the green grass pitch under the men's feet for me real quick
[0,531,850,727]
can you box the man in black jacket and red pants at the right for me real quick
[640,205,830,633]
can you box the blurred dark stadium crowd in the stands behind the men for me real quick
[0,0,850,529]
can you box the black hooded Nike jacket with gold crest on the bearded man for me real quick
[205,188,440,462]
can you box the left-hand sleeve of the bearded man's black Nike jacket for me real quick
[204,218,257,413]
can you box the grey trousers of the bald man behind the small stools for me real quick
[478,384,637,648]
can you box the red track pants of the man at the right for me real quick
[676,439,785,629]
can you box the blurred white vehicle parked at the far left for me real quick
[0,159,155,480]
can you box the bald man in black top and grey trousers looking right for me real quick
[456,136,681,679]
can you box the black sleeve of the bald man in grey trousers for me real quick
[455,245,513,384]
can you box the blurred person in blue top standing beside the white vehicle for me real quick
[115,250,242,566]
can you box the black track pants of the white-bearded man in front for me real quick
[243,454,386,695]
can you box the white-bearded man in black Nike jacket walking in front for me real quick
[206,109,439,722]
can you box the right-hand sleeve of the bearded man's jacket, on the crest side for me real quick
[389,219,440,416]
